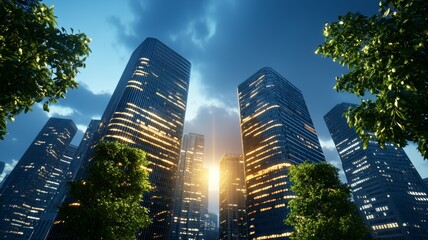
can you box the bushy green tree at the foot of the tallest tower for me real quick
[59,142,151,240]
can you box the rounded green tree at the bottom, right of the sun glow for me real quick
[285,162,368,240]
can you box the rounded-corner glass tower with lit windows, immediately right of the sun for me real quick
[238,67,324,239]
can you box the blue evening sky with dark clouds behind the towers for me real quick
[0,0,428,212]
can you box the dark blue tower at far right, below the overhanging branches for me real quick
[324,103,428,239]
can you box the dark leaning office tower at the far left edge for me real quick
[0,118,77,239]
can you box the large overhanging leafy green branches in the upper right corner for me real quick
[315,0,428,159]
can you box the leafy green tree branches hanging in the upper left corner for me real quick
[0,0,90,139]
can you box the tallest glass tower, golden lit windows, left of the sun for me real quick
[94,38,190,239]
